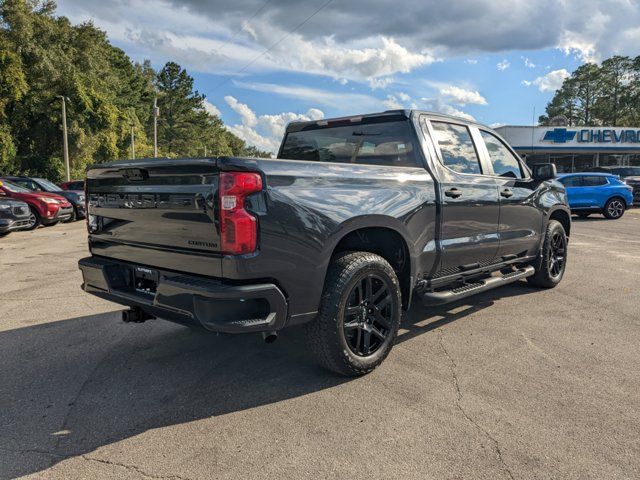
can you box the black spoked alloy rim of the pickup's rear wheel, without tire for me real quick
[343,274,393,357]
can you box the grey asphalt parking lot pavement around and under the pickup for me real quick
[0,214,640,479]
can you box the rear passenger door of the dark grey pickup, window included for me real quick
[423,118,499,276]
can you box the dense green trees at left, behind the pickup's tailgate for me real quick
[0,0,270,180]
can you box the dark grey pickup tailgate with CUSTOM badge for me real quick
[86,159,222,277]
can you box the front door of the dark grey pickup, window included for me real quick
[479,129,543,260]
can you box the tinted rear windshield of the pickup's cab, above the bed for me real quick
[278,121,420,167]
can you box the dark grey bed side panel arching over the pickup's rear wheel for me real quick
[219,159,436,315]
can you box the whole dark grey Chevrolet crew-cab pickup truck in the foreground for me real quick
[79,110,571,375]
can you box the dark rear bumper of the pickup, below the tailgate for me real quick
[78,256,287,333]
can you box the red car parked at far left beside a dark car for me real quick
[0,178,73,230]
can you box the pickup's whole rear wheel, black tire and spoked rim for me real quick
[306,252,402,377]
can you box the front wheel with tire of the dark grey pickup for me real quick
[527,220,568,288]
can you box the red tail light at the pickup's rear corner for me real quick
[219,172,262,255]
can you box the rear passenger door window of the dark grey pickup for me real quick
[431,122,482,175]
